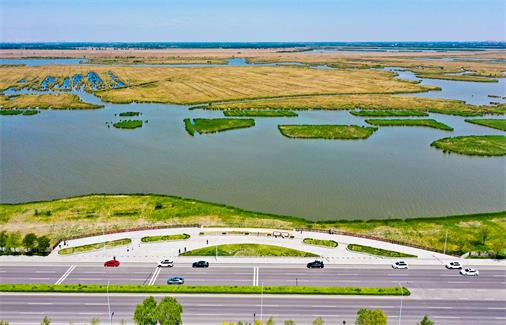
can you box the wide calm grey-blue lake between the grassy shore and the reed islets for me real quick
[0,60,506,219]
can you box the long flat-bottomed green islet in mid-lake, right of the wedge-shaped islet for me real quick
[278,125,377,140]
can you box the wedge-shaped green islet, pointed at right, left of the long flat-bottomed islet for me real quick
[184,118,255,135]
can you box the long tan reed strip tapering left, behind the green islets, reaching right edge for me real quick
[210,94,506,116]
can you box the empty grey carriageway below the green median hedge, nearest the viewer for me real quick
[0,294,506,325]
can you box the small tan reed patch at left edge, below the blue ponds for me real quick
[0,93,104,109]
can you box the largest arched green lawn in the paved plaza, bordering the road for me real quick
[181,244,318,257]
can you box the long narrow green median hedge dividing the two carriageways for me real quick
[0,284,411,296]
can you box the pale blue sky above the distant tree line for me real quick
[0,0,506,42]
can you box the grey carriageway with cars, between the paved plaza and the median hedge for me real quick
[0,261,506,289]
